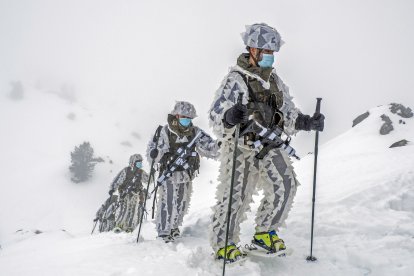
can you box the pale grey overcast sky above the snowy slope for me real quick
[0,0,414,153]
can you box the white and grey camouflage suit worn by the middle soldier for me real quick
[147,111,219,236]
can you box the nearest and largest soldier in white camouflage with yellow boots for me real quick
[209,23,324,262]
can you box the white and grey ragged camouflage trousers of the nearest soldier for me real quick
[210,143,299,251]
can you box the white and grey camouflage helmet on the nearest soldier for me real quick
[241,23,283,52]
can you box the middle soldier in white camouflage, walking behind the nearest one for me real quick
[147,101,219,242]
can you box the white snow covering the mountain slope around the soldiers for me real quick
[0,87,414,276]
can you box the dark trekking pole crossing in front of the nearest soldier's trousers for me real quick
[223,92,243,276]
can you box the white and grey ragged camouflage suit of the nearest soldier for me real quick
[209,65,300,251]
